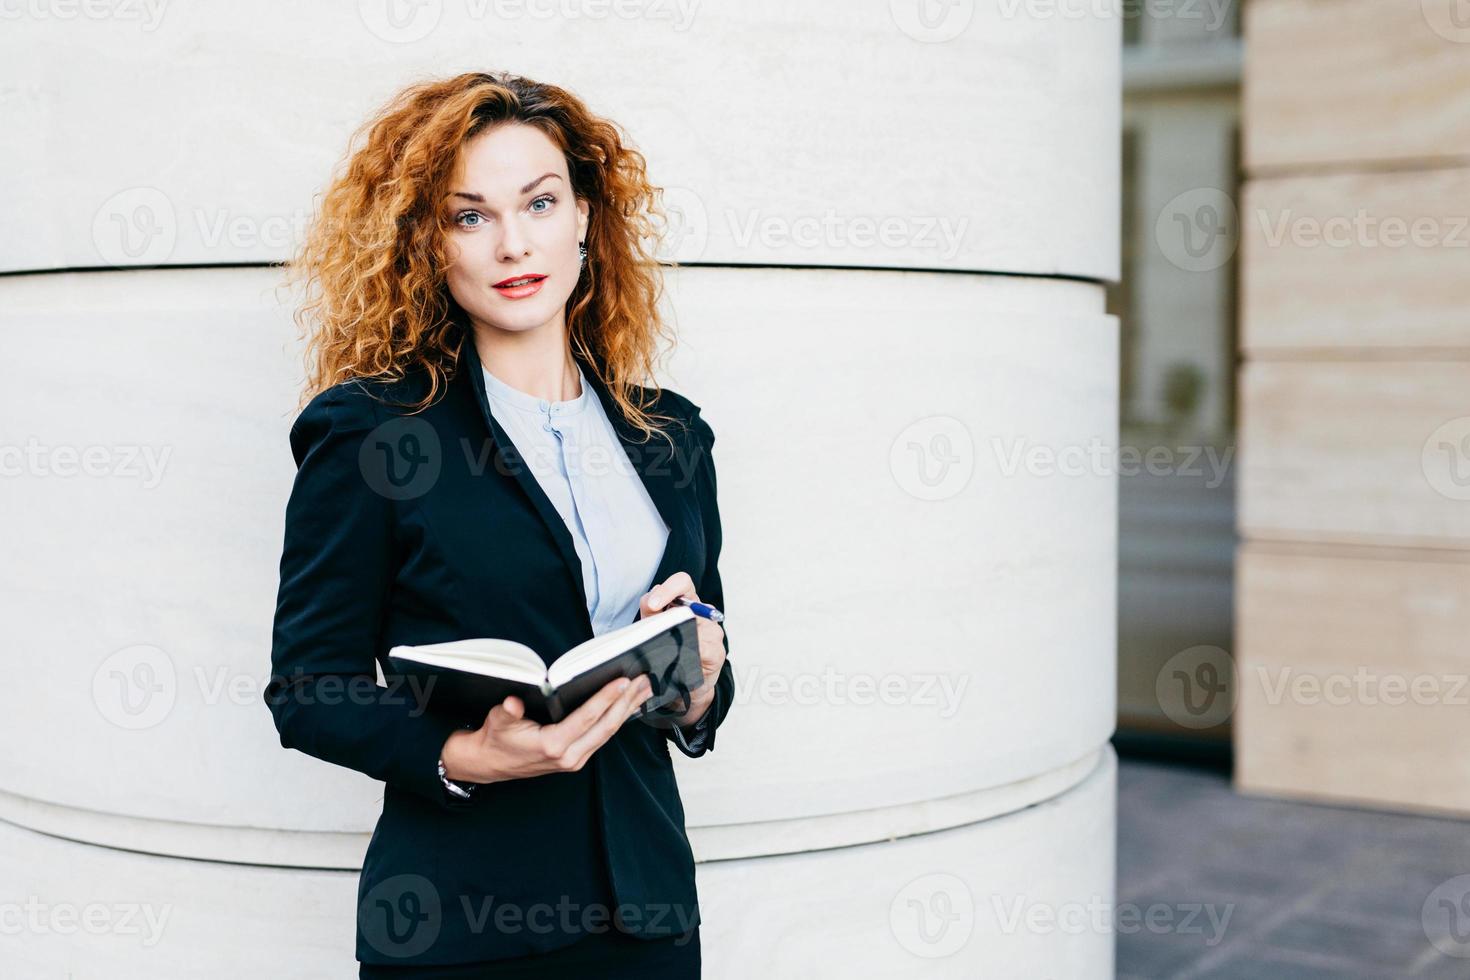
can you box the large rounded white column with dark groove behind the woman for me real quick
[0,0,1119,979]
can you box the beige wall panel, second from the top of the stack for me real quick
[1241,170,1470,357]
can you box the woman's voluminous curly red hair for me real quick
[277,72,672,438]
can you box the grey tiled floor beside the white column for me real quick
[1114,749,1470,980]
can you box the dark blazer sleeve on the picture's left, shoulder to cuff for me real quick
[265,385,467,810]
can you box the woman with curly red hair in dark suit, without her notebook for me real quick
[266,73,734,977]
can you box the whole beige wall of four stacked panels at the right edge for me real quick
[1235,0,1470,813]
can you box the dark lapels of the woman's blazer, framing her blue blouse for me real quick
[459,328,686,633]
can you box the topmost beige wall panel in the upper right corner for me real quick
[1242,0,1470,170]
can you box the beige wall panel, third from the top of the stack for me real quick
[1239,361,1470,548]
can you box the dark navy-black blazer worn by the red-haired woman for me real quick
[265,328,735,964]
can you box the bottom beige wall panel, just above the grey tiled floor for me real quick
[1235,545,1470,813]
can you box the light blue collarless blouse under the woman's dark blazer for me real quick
[484,364,709,754]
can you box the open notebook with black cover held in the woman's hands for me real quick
[388,605,704,726]
